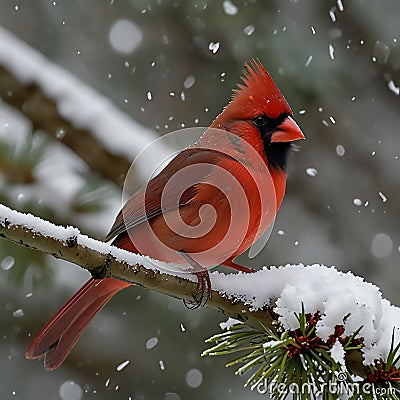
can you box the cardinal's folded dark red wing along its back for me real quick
[106,148,228,240]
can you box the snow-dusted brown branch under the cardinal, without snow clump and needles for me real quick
[0,204,384,384]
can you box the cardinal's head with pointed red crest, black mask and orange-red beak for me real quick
[211,60,304,171]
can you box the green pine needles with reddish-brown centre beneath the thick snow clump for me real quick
[202,307,400,400]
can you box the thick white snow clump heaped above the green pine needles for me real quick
[211,264,400,365]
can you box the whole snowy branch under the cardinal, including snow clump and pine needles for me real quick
[0,205,400,398]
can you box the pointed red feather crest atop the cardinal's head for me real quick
[227,59,292,118]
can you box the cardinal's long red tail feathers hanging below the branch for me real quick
[25,278,130,371]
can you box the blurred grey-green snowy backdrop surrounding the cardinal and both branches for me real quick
[0,0,400,400]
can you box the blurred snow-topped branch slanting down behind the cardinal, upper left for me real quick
[0,27,170,186]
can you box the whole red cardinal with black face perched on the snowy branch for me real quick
[26,61,304,370]
